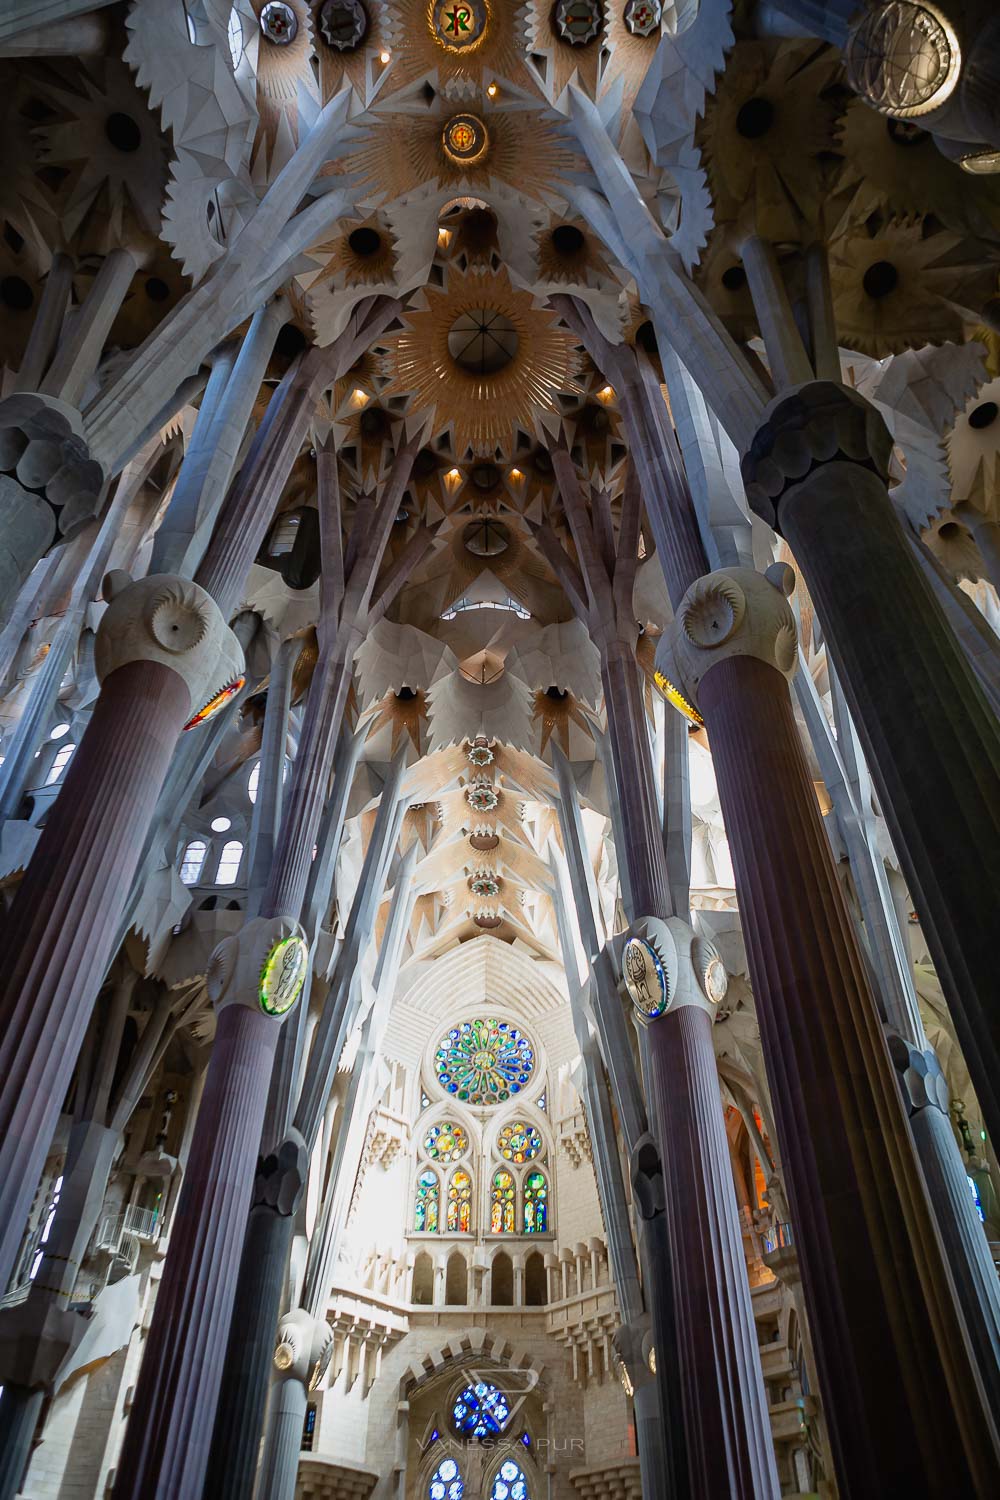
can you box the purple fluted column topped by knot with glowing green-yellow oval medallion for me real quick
[114,918,309,1500]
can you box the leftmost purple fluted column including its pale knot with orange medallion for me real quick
[0,575,243,1286]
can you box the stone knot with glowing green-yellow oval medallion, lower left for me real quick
[205,917,309,1023]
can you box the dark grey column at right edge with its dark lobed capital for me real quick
[742,381,1000,1140]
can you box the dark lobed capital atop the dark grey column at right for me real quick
[741,380,892,531]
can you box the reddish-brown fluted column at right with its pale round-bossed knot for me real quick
[657,564,997,1496]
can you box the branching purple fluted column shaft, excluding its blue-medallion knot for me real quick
[537,446,778,1497]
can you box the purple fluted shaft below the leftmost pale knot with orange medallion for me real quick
[0,662,190,1286]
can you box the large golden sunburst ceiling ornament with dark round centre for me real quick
[388,270,579,455]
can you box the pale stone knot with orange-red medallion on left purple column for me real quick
[94,572,244,728]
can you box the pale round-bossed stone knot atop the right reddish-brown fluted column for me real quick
[657,563,798,720]
